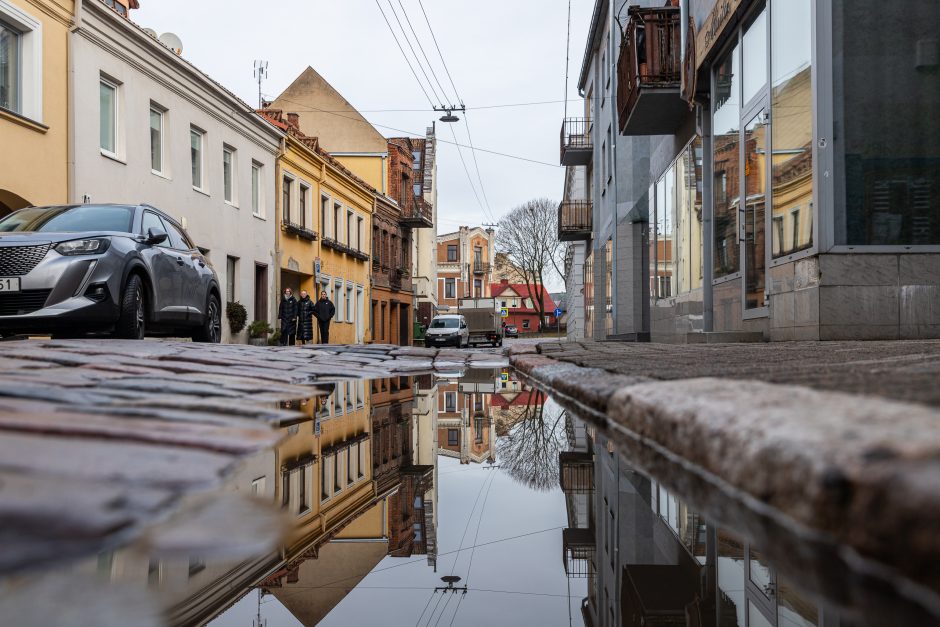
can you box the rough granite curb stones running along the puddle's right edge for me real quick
[510,346,940,604]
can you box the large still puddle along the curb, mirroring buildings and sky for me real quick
[0,369,937,627]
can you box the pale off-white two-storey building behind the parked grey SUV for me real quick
[69,2,282,341]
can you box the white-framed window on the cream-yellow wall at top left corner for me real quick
[0,0,43,122]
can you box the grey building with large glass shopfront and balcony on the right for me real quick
[563,0,940,342]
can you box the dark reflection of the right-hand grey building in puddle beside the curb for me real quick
[559,418,824,627]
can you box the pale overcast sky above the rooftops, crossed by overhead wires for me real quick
[131,0,594,233]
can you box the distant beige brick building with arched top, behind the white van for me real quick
[436,226,496,311]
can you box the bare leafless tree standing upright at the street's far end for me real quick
[496,198,565,328]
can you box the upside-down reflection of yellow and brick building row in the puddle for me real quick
[66,377,436,624]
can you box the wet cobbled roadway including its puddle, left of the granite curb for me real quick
[0,342,940,627]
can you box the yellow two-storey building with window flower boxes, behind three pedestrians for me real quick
[262,108,376,344]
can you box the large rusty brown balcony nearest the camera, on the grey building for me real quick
[617,7,689,135]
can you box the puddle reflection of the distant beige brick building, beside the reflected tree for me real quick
[437,370,498,464]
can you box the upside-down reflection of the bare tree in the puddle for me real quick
[496,391,567,491]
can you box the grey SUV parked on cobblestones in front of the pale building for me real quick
[0,204,222,342]
